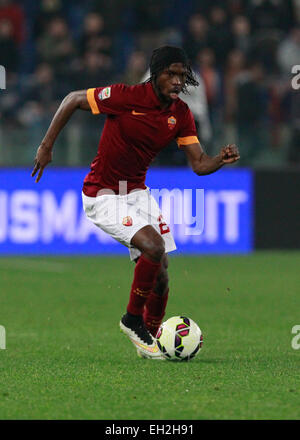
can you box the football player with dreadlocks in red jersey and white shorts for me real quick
[32,46,239,359]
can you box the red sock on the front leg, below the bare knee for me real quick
[127,255,160,315]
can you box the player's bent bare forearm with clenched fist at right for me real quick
[183,142,240,176]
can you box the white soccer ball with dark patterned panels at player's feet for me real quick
[156,316,203,361]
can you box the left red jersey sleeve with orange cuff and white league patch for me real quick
[87,84,130,115]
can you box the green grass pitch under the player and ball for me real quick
[0,252,300,420]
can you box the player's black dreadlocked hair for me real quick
[147,46,199,93]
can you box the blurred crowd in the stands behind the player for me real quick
[0,0,300,167]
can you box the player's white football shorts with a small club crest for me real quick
[82,188,176,260]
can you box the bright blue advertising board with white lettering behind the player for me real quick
[0,168,253,255]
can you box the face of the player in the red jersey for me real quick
[155,63,187,102]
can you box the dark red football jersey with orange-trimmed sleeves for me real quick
[83,82,199,197]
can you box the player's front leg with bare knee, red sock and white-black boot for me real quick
[120,225,165,359]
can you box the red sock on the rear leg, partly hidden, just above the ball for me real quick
[143,289,169,336]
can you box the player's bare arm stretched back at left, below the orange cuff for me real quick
[31,90,91,182]
